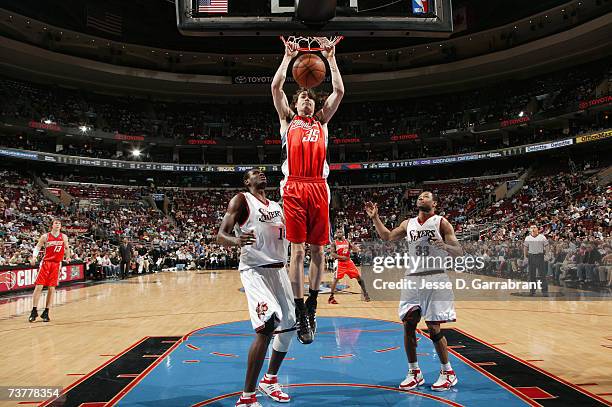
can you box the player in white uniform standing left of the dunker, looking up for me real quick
[217,169,295,407]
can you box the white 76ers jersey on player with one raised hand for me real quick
[406,215,448,273]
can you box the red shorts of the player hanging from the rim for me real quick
[281,176,330,246]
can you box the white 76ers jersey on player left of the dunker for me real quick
[235,192,287,270]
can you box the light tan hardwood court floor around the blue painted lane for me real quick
[0,271,612,406]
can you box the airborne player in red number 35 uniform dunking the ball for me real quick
[272,39,344,344]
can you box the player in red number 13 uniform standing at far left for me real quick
[28,219,70,322]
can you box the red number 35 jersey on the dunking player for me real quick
[282,115,329,178]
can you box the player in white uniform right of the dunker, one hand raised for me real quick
[365,191,463,391]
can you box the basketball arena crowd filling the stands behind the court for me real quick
[0,60,612,288]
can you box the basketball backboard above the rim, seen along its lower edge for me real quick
[176,0,453,38]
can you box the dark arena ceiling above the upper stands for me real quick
[2,0,572,54]
